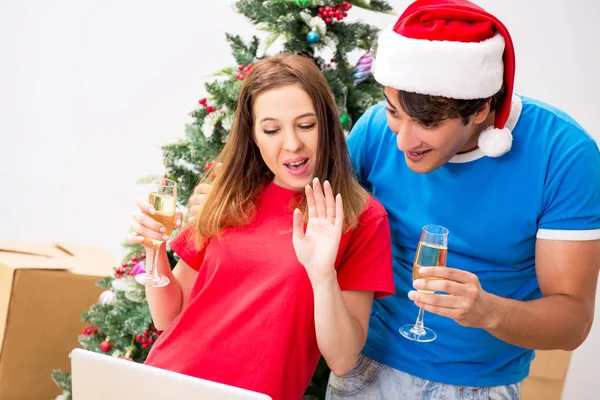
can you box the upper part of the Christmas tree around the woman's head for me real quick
[163,0,392,204]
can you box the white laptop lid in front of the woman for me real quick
[70,349,271,400]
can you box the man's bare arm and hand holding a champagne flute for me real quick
[409,239,600,350]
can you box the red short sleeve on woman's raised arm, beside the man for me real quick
[337,198,394,298]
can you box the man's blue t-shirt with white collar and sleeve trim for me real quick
[348,96,600,386]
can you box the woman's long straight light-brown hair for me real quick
[196,54,367,243]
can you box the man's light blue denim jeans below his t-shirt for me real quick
[325,354,521,400]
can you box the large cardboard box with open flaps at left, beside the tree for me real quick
[0,241,116,400]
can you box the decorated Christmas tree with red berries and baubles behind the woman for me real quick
[52,0,391,400]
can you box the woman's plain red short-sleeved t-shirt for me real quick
[145,183,394,400]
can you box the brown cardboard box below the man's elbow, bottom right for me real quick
[522,350,571,400]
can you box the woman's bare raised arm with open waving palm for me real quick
[293,179,391,375]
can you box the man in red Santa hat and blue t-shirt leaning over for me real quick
[188,0,600,400]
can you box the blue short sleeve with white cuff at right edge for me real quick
[537,141,600,240]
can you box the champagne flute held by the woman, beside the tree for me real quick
[135,178,177,287]
